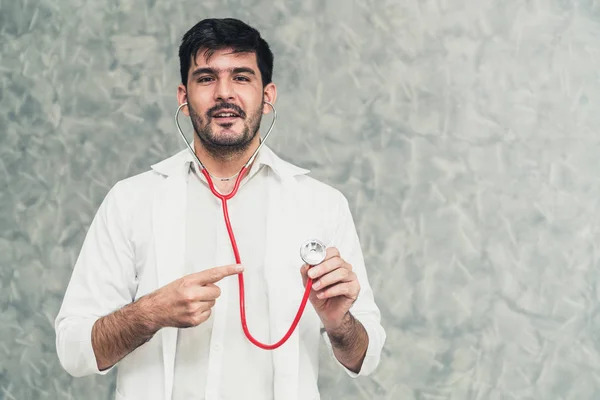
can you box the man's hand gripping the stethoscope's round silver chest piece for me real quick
[300,247,360,332]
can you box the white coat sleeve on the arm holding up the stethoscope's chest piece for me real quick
[322,193,386,378]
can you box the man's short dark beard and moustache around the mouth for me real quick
[188,98,264,160]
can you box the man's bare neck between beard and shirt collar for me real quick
[194,132,260,180]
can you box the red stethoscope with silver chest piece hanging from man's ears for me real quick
[175,101,326,350]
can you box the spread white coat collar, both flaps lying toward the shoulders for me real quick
[152,145,309,179]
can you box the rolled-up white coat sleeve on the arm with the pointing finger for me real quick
[55,183,137,377]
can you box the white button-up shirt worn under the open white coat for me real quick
[173,157,273,400]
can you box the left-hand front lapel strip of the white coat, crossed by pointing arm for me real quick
[152,173,187,399]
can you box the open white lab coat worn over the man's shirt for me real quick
[56,146,385,400]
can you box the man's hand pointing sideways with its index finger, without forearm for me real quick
[145,264,243,330]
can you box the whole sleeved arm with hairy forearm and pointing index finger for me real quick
[55,184,239,377]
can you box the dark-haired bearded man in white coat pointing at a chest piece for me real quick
[56,19,385,400]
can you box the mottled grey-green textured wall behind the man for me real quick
[0,0,600,400]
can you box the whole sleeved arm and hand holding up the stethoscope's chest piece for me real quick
[301,194,386,377]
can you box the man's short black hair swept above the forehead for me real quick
[179,18,273,87]
